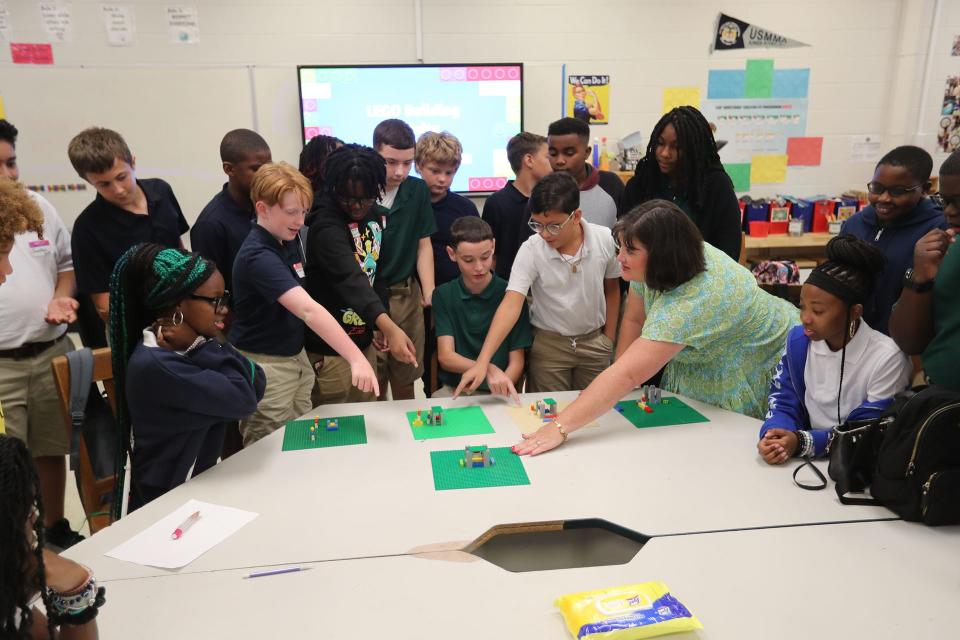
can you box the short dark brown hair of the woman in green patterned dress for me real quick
[613,200,707,291]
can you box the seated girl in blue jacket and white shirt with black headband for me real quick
[757,235,911,464]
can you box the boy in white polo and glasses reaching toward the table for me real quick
[456,173,620,395]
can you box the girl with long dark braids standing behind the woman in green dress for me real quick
[620,107,741,260]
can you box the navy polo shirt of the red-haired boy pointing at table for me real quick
[230,224,305,356]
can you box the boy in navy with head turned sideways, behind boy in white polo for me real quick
[483,132,553,280]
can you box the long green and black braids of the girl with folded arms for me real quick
[109,243,216,519]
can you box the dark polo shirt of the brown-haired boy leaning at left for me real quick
[71,178,190,294]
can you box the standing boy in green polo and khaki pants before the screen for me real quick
[373,119,437,400]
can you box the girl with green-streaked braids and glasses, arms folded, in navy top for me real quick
[109,244,266,518]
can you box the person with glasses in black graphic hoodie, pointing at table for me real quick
[306,144,416,404]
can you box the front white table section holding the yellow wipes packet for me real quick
[92,521,960,640]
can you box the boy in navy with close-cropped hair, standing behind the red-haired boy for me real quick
[190,129,273,291]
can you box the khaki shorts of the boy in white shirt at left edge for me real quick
[0,335,73,457]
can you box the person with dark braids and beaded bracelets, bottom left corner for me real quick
[0,434,105,640]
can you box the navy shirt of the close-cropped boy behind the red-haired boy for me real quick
[190,184,256,291]
